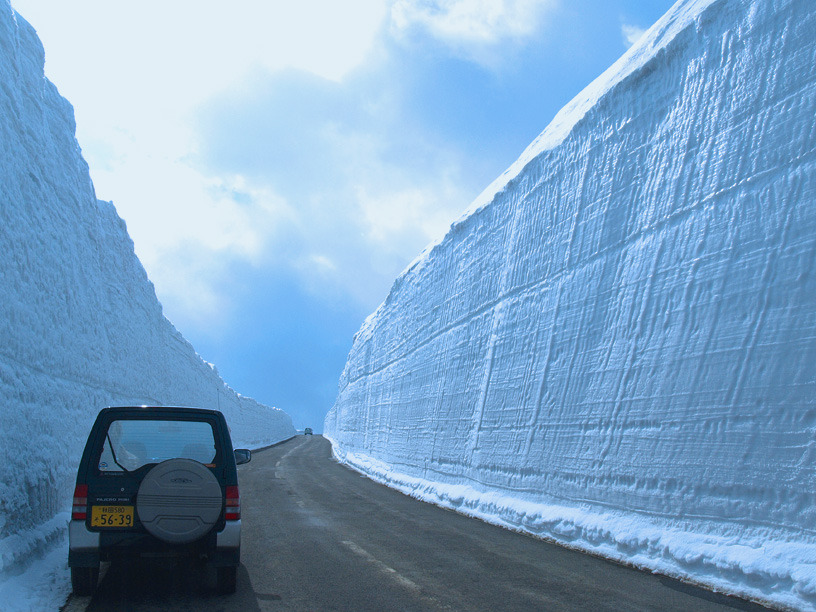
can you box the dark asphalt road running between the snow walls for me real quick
[75,436,764,612]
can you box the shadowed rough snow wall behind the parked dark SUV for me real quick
[0,0,295,572]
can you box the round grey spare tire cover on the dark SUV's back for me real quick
[136,459,223,544]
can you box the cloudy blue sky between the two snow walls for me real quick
[11,0,673,432]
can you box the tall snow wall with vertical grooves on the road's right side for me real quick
[325,0,816,609]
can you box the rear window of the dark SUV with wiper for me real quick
[99,419,216,472]
